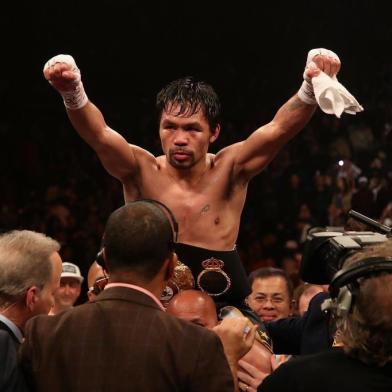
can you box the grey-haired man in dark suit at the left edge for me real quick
[0,230,61,392]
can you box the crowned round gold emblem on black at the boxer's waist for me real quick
[197,257,231,297]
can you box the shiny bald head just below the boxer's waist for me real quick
[166,290,218,329]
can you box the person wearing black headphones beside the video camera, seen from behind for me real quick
[258,239,392,392]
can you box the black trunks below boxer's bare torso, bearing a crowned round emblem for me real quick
[175,243,251,308]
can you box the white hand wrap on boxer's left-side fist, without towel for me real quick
[44,54,88,110]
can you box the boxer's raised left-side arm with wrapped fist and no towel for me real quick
[44,55,150,180]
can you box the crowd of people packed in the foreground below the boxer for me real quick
[0,200,392,392]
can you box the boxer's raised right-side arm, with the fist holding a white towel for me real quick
[229,49,340,181]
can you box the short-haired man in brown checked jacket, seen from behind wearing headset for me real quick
[21,201,254,392]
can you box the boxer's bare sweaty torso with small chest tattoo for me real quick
[123,154,247,250]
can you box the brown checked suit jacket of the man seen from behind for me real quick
[21,287,233,392]
